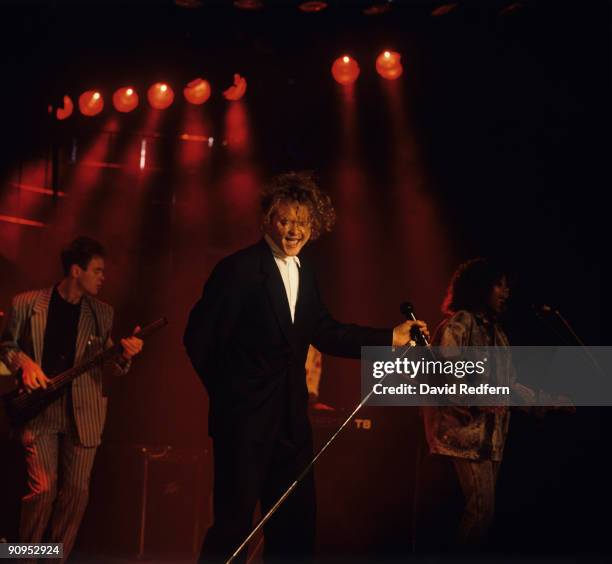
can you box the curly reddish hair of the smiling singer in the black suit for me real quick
[261,171,336,241]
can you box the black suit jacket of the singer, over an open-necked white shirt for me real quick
[184,239,392,448]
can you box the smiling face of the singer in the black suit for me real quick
[264,202,311,257]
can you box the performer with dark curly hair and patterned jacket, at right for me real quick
[423,258,536,550]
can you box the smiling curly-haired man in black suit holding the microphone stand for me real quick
[184,173,427,561]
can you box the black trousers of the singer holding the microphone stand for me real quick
[200,437,316,562]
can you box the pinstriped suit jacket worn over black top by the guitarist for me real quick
[0,288,128,446]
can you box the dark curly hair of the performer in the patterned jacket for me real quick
[442,257,509,315]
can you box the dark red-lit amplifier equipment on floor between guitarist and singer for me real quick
[79,444,212,562]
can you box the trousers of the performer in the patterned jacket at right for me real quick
[452,457,500,549]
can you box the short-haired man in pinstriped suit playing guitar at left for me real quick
[0,237,143,560]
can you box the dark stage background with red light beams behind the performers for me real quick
[0,0,610,557]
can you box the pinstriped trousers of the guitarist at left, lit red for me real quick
[20,394,97,562]
